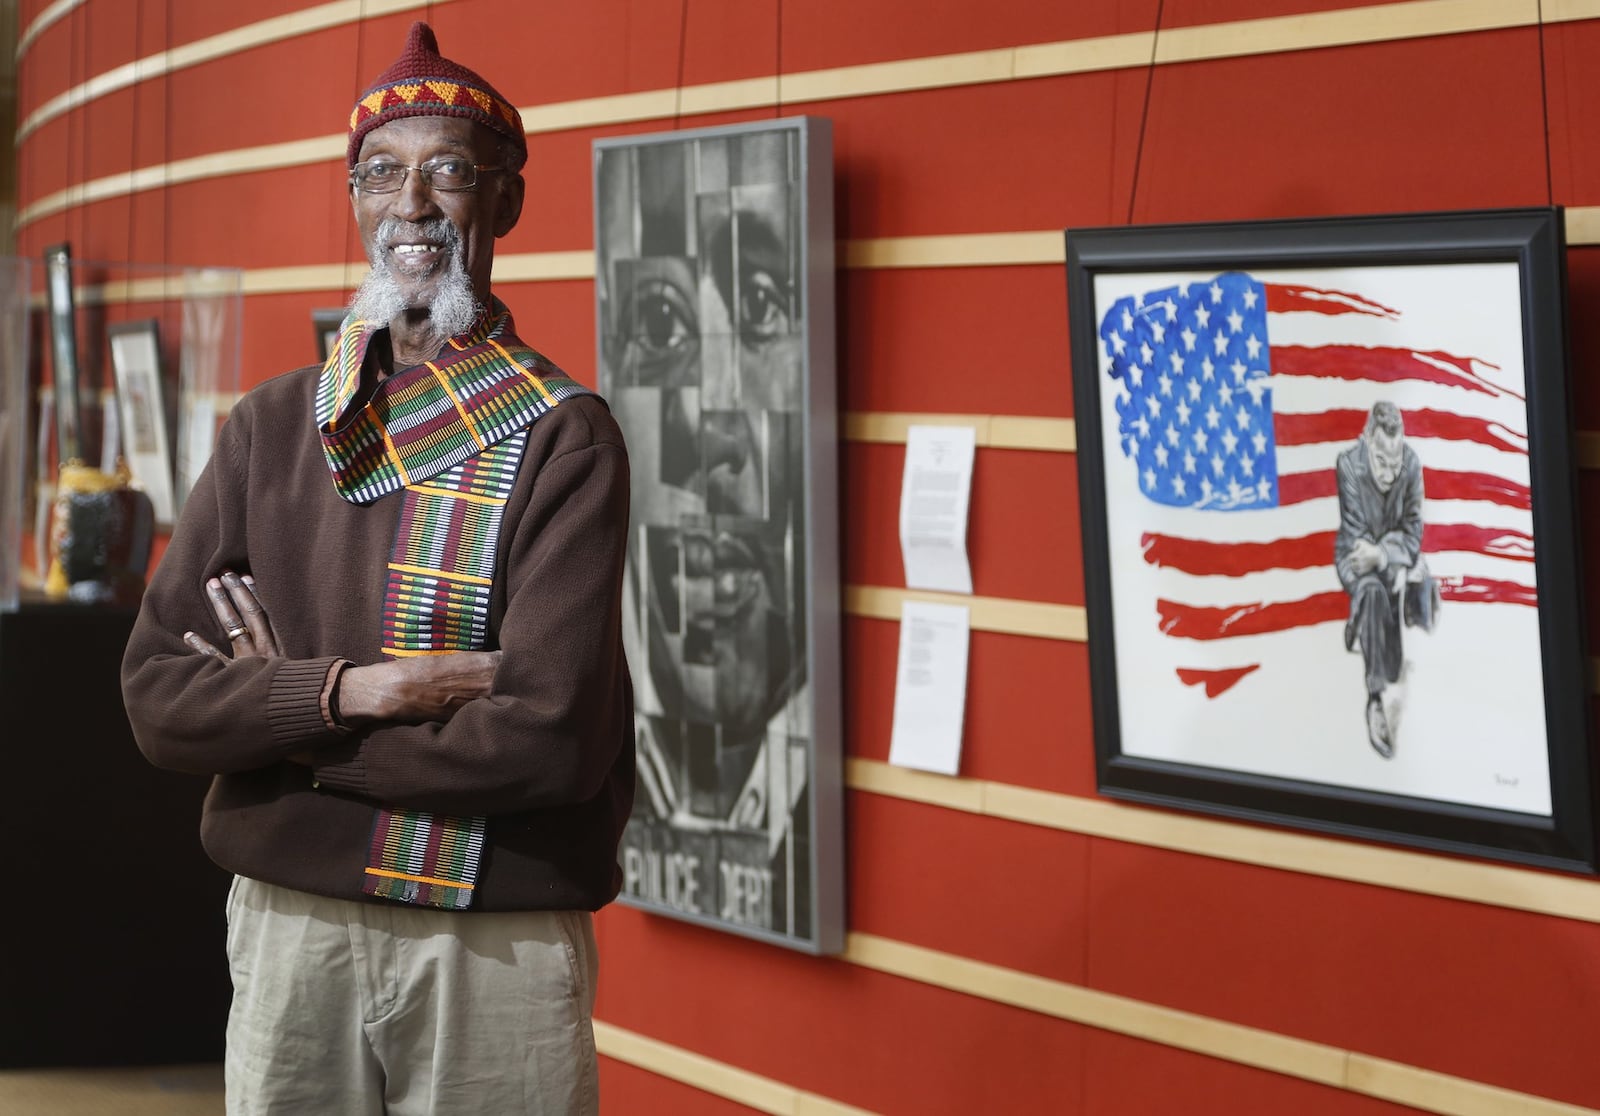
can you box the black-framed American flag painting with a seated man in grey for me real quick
[1066,208,1595,871]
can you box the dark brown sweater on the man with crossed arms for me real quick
[122,368,634,911]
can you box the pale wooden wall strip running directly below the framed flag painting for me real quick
[845,758,1600,923]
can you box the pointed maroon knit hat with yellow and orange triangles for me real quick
[346,19,528,171]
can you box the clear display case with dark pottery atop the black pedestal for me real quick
[0,254,243,611]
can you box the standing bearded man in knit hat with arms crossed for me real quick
[123,22,634,1116]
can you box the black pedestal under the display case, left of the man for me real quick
[0,603,230,1066]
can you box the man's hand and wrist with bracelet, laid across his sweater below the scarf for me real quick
[339,651,501,727]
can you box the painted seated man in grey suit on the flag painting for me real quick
[1333,400,1437,759]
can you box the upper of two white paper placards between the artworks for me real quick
[901,425,978,593]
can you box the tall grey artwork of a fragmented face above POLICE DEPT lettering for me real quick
[594,117,845,953]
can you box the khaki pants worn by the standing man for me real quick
[226,876,600,1116]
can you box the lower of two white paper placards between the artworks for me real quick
[890,601,970,775]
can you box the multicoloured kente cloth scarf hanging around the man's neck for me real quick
[317,302,590,910]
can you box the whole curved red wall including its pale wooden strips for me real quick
[16,0,1600,1116]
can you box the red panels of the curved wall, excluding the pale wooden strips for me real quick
[18,0,1600,1116]
